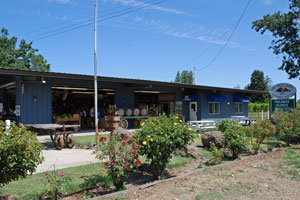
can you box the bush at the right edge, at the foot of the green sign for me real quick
[273,108,300,145]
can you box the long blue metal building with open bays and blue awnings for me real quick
[0,69,268,124]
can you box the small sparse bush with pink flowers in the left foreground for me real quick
[41,170,72,200]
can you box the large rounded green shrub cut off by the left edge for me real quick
[0,121,43,186]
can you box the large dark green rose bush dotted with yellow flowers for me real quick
[137,114,196,179]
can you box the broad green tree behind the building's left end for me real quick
[0,28,50,72]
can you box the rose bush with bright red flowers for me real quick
[94,132,141,190]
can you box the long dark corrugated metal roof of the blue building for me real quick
[0,68,269,94]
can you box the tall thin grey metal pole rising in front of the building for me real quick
[94,0,99,145]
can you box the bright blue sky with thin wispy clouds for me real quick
[0,0,300,98]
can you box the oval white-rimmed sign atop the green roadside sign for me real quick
[269,83,296,99]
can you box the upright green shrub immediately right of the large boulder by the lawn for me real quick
[224,124,247,158]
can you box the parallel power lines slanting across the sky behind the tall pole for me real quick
[31,0,167,41]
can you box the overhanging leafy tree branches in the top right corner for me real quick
[252,0,300,79]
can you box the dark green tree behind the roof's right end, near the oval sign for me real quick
[245,69,272,103]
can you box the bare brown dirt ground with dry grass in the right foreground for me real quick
[100,146,300,200]
